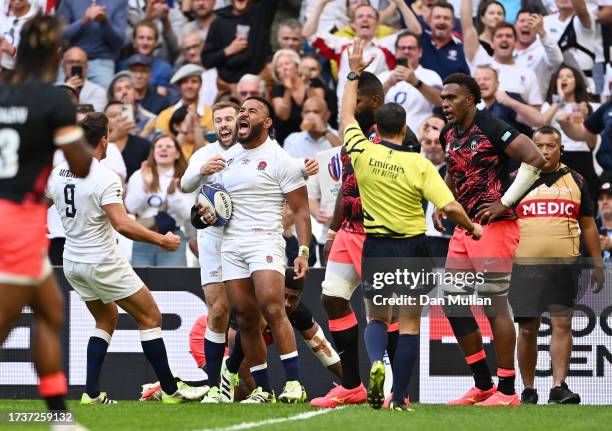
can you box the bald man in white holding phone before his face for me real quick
[62,46,106,112]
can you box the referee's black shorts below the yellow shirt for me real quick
[361,235,435,316]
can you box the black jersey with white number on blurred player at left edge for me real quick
[0,81,76,203]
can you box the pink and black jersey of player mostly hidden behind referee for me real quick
[340,126,380,233]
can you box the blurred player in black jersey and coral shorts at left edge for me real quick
[0,16,91,418]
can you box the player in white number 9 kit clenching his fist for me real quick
[45,113,206,404]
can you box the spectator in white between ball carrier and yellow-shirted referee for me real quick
[306,147,342,266]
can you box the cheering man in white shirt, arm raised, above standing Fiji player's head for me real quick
[461,20,542,108]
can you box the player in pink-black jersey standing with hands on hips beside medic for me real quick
[434,74,546,406]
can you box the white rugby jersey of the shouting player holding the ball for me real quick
[219,138,306,239]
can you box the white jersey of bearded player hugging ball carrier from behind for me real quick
[181,141,231,238]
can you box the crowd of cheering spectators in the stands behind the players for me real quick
[0,0,612,266]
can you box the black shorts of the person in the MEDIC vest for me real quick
[509,263,580,322]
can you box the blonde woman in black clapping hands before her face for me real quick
[271,49,325,145]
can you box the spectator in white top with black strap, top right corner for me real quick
[544,0,603,85]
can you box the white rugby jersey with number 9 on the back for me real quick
[45,159,123,263]
